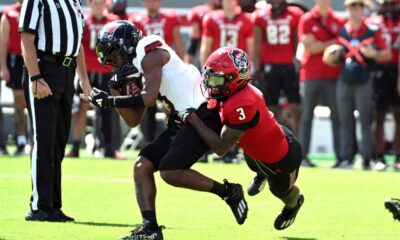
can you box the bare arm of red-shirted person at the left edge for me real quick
[0,14,10,81]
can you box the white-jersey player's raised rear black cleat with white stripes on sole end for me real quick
[224,179,249,224]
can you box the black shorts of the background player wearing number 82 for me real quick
[261,64,301,106]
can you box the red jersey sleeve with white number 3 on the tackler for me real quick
[223,104,260,130]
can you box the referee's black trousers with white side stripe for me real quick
[23,60,75,210]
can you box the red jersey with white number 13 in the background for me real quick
[202,8,253,52]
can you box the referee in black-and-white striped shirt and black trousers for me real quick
[19,0,91,222]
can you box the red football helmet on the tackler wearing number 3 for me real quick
[202,47,251,99]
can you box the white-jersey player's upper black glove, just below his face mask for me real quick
[108,64,142,91]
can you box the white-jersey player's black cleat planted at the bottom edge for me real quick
[120,221,165,240]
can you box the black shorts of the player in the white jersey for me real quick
[139,103,222,171]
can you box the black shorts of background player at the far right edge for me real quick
[372,64,400,112]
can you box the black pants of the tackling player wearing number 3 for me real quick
[245,126,302,198]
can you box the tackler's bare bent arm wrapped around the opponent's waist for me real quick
[188,114,244,156]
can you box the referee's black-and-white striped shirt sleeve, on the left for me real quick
[18,0,42,33]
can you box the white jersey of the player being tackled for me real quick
[133,35,206,112]
